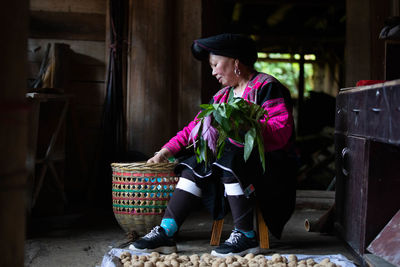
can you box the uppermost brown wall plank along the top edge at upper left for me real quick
[29,0,106,14]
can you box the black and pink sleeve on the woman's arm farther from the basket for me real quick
[259,82,294,151]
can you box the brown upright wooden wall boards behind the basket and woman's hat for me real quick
[127,0,202,156]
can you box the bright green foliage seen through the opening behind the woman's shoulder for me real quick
[254,54,314,98]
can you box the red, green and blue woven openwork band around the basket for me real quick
[112,168,178,215]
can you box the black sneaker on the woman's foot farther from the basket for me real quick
[211,229,260,257]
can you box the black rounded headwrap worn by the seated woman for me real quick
[192,33,257,67]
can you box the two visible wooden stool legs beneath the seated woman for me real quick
[210,205,269,249]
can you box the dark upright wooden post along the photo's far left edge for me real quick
[0,1,29,267]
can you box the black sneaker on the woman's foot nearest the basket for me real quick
[129,226,177,254]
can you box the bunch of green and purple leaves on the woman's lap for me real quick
[189,98,268,171]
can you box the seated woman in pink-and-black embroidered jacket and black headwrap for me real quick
[130,34,295,255]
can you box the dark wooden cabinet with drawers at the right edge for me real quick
[335,80,400,256]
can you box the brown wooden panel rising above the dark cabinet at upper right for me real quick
[345,0,390,87]
